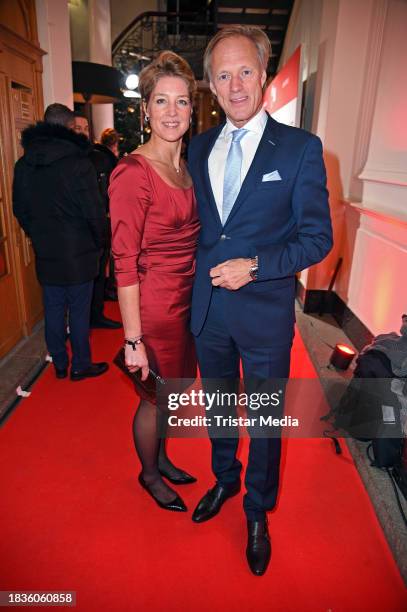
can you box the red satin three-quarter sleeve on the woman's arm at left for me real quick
[109,155,151,287]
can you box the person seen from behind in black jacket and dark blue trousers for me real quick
[13,104,108,380]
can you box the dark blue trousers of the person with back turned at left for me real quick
[42,280,93,370]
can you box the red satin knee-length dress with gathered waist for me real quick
[109,154,199,378]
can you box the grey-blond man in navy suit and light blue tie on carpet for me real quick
[188,26,332,575]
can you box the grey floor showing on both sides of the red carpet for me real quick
[0,306,407,583]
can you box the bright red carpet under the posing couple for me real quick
[0,305,406,612]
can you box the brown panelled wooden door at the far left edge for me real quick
[0,0,44,357]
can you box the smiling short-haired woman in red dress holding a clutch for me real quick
[109,51,199,511]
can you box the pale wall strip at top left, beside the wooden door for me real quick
[35,0,73,109]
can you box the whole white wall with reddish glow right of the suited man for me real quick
[282,0,407,333]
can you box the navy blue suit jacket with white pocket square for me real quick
[188,116,332,348]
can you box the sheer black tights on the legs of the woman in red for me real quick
[133,400,186,503]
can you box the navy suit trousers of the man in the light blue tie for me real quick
[195,289,292,520]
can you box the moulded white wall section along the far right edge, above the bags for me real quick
[346,0,407,333]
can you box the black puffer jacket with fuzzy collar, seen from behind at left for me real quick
[13,122,106,285]
